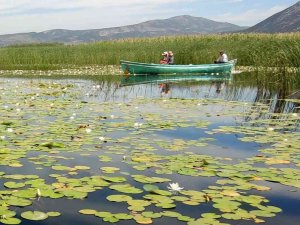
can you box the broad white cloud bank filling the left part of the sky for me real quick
[0,0,196,34]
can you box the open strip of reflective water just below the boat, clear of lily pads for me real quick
[1,73,300,115]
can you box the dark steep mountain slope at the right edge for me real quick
[243,1,300,33]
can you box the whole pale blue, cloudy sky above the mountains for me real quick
[0,0,298,34]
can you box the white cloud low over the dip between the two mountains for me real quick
[212,5,287,26]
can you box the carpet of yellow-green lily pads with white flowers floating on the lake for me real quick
[0,77,300,225]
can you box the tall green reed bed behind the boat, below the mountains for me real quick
[0,33,300,70]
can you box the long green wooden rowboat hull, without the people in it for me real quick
[120,60,236,75]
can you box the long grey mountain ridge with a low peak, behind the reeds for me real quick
[0,15,246,45]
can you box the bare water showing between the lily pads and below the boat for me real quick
[0,74,300,225]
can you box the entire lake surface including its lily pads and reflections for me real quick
[0,73,300,225]
